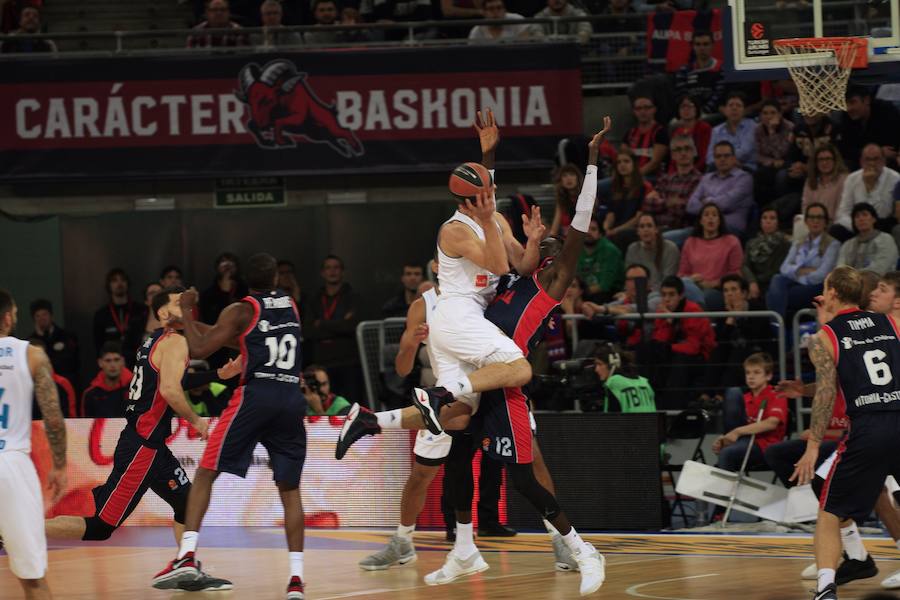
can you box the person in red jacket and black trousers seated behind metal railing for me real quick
[640,276,716,409]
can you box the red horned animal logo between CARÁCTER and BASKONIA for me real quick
[235,59,364,158]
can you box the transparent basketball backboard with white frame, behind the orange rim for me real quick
[723,0,900,80]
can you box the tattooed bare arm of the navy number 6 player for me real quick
[790,330,837,485]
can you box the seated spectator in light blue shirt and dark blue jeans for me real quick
[766,202,841,316]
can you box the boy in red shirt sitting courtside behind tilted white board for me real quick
[713,352,788,471]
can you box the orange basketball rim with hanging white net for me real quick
[774,37,869,115]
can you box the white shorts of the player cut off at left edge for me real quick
[0,451,47,579]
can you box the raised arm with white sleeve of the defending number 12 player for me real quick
[546,117,612,298]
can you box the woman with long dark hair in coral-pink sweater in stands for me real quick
[678,202,744,311]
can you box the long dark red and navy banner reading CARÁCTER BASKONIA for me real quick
[0,45,581,179]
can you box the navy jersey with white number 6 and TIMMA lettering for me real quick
[822,308,900,419]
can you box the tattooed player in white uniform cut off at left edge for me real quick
[0,290,66,600]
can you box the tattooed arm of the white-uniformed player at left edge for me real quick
[28,346,66,502]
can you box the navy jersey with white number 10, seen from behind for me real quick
[239,290,301,390]
